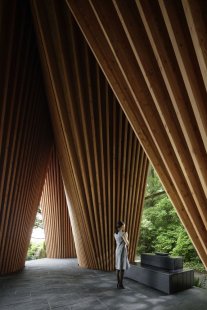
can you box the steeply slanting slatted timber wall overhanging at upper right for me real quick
[67,0,207,267]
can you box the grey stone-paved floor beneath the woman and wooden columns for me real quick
[0,259,207,310]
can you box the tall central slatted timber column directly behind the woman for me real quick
[32,1,148,270]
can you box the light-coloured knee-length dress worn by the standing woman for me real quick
[114,231,130,270]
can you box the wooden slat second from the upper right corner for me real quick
[159,1,207,150]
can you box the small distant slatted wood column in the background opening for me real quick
[40,148,76,258]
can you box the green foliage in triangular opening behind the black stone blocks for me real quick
[137,167,204,271]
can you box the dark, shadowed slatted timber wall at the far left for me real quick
[0,1,52,274]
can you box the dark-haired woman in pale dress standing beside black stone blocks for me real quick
[114,221,130,289]
